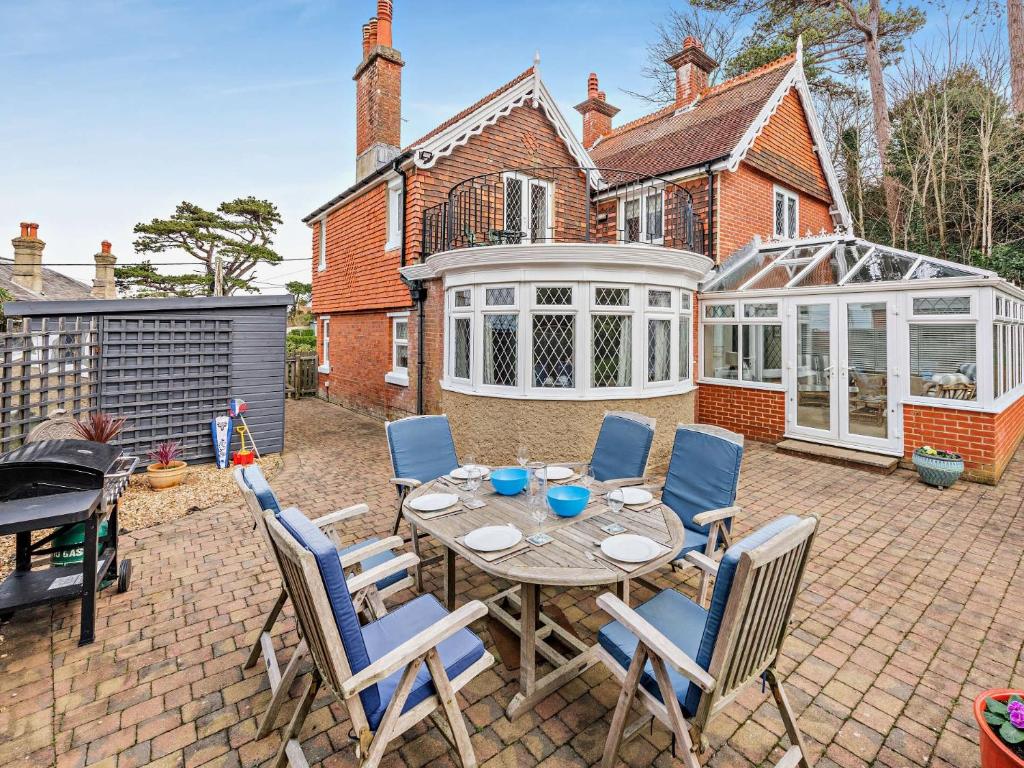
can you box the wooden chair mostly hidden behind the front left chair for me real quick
[234,465,416,738]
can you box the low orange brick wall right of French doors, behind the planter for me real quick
[903,398,1024,483]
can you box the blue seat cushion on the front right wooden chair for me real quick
[597,590,708,717]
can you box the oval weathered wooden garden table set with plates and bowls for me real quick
[402,477,686,720]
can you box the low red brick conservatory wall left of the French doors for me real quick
[697,384,785,442]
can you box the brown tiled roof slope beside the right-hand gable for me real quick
[590,54,796,175]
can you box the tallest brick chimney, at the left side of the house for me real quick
[352,0,406,181]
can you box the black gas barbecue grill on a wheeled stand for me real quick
[0,440,138,645]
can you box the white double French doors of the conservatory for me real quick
[786,294,902,454]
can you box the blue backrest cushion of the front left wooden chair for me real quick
[278,507,380,710]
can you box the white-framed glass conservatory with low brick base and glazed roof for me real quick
[696,234,1024,480]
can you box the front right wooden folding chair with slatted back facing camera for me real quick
[596,515,818,768]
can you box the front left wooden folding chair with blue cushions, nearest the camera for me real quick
[264,508,495,768]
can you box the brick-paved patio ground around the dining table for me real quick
[0,400,1024,768]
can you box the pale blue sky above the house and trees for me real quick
[0,0,995,293]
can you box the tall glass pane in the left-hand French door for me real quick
[797,304,831,432]
